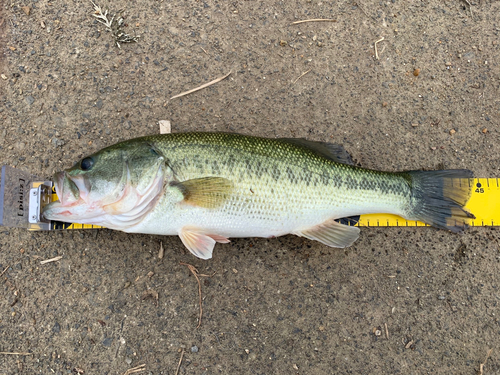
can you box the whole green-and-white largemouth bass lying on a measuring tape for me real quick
[43,132,474,259]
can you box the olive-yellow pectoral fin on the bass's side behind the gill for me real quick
[170,177,233,208]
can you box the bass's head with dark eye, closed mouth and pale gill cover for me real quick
[43,141,171,229]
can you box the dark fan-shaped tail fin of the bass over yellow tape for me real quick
[403,169,475,232]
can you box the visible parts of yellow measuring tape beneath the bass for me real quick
[46,178,500,229]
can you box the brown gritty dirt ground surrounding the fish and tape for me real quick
[0,0,500,375]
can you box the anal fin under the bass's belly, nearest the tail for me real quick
[294,220,359,248]
